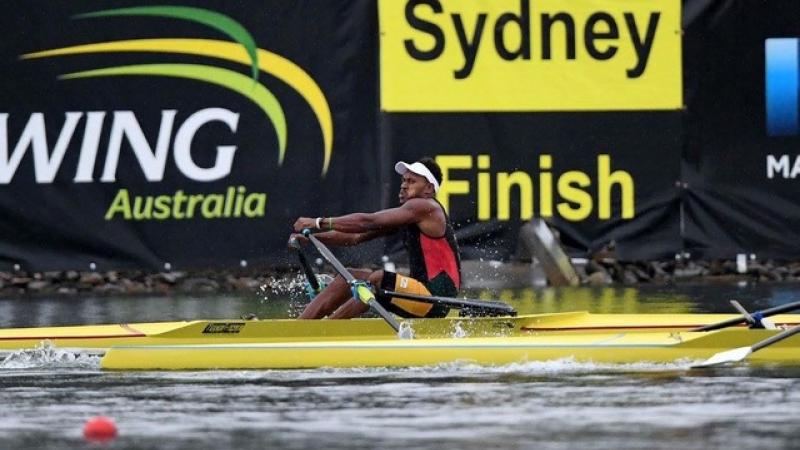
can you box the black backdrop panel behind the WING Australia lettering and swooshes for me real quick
[0,0,380,270]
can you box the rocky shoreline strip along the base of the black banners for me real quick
[0,258,800,297]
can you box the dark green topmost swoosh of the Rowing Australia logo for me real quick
[73,6,258,80]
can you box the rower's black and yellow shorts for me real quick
[377,272,458,318]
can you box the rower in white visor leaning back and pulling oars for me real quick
[290,158,461,319]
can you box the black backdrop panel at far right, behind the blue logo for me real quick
[682,0,800,259]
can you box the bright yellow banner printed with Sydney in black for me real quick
[379,0,683,112]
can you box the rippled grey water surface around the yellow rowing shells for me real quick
[0,284,800,449]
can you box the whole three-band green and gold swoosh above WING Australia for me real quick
[21,6,333,177]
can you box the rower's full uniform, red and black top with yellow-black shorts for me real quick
[378,202,461,317]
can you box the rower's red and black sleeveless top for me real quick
[404,199,461,295]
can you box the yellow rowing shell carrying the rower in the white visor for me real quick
[0,311,800,352]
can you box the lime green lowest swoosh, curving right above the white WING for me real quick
[59,64,286,160]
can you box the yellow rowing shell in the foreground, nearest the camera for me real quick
[101,328,800,370]
